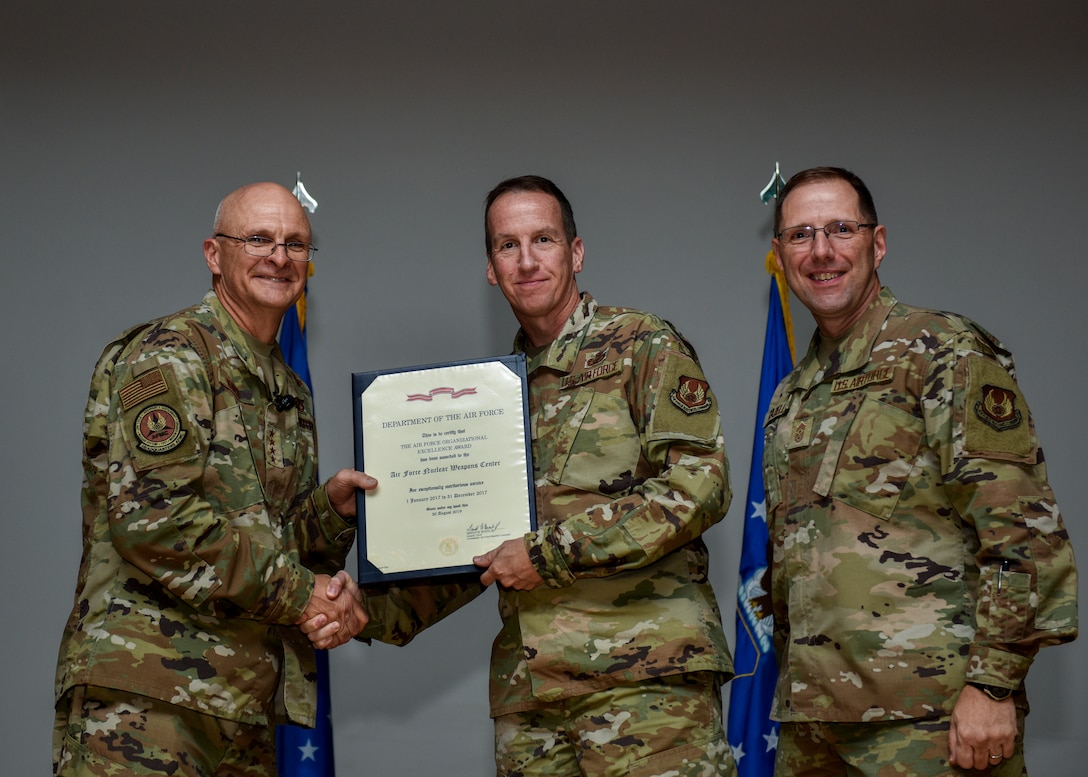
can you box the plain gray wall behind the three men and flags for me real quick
[0,0,1088,777]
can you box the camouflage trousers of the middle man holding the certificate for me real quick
[495,673,737,777]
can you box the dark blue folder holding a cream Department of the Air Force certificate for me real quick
[351,354,536,583]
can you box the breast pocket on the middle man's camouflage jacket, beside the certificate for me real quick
[545,386,642,495]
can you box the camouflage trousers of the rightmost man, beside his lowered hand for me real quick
[775,710,1027,777]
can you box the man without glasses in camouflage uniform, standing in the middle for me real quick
[475,176,733,777]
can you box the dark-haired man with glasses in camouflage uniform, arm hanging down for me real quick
[764,168,1077,777]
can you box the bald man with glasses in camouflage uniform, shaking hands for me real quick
[53,184,373,777]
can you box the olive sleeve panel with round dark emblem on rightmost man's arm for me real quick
[964,357,1036,459]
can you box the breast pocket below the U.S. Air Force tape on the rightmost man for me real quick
[830,398,922,519]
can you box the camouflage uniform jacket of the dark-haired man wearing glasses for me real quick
[764,288,1077,722]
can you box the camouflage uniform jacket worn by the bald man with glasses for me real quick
[55,292,355,726]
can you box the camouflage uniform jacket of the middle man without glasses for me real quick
[491,294,732,716]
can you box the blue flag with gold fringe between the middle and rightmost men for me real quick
[727,252,793,777]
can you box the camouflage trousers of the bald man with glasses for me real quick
[53,686,276,777]
